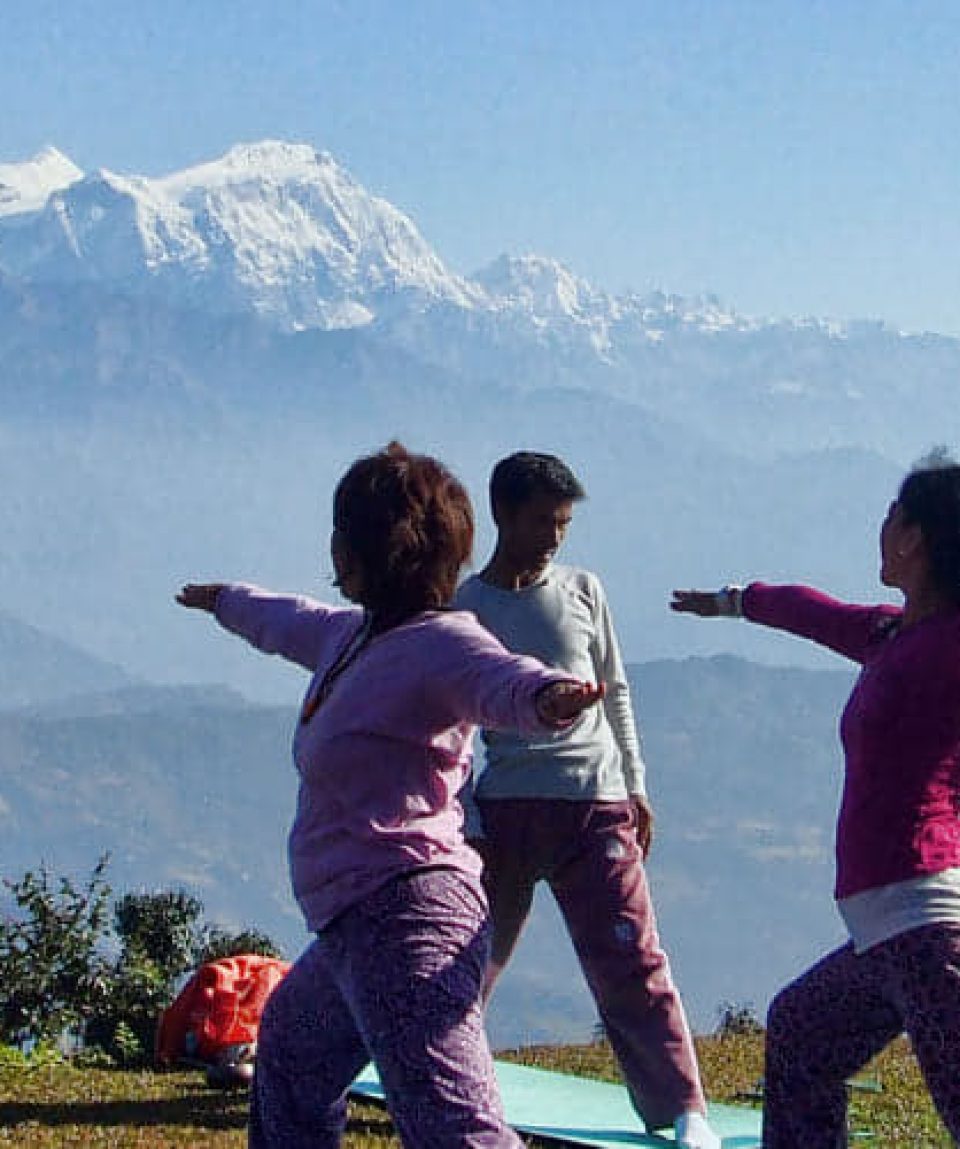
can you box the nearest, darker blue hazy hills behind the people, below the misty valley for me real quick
[0,627,850,1044]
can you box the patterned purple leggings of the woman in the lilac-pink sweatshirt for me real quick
[248,869,521,1149]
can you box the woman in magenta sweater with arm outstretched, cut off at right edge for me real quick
[672,455,960,1149]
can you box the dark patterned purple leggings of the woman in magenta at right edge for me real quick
[764,925,960,1149]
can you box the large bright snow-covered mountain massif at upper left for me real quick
[0,142,477,331]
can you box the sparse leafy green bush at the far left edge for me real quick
[0,854,110,1044]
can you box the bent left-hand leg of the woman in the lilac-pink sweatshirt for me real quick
[248,942,370,1149]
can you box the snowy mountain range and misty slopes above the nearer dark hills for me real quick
[0,141,960,701]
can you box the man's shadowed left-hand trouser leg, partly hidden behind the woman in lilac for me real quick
[478,799,542,1001]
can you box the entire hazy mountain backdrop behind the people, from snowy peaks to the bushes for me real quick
[0,140,960,1036]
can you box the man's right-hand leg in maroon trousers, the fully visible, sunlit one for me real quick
[549,802,706,1129]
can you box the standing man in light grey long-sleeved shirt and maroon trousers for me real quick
[456,452,720,1149]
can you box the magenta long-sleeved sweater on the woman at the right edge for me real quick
[743,583,960,899]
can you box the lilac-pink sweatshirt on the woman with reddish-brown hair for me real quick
[216,585,570,931]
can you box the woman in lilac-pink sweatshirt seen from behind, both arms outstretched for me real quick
[177,444,602,1149]
